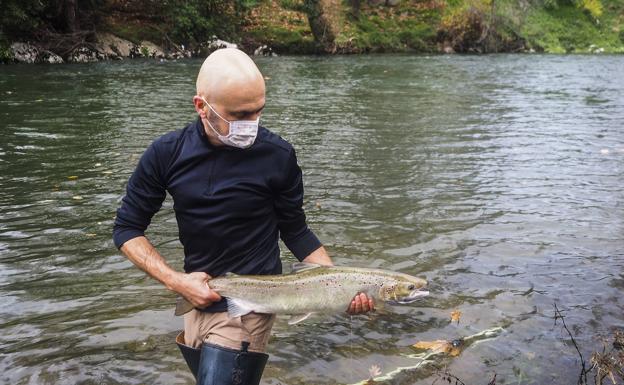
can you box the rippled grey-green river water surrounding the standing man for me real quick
[0,55,624,385]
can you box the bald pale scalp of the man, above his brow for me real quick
[196,48,264,105]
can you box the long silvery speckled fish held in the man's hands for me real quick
[175,263,428,323]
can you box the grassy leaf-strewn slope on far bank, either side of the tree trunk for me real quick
[244,0,624,53]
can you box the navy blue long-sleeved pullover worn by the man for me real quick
[113,119,321,312]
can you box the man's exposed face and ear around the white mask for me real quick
[194,79,265,144]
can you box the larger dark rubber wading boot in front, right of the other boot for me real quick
[197,341,269,385]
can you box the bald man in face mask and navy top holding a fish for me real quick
[113,49,373,385]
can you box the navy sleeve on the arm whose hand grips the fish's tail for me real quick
[113,143,166,248]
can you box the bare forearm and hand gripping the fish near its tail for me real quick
[121,237,221,308]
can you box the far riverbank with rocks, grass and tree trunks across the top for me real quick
[0,0,624,63]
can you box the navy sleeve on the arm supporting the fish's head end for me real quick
[275,150,321,261]
